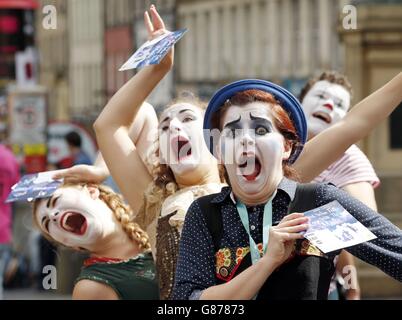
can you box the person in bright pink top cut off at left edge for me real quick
[0,144,20,300]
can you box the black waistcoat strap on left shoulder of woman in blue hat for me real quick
[197,194,223,252]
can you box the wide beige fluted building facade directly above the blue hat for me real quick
[177,0,342,83]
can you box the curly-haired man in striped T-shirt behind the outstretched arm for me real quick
[299,71,380,300]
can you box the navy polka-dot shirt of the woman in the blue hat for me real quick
[173,178,402,299]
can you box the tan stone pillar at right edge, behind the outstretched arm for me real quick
[340,1,402,297]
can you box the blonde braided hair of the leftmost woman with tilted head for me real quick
[33,183,151,251]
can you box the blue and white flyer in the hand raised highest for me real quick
[119,29,187,71]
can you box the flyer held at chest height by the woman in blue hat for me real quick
[304,201,377,253]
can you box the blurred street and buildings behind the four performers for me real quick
[0,0,402,300]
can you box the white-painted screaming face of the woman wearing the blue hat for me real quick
[220,102,290,204]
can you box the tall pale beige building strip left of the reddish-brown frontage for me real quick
[67,0,105,125]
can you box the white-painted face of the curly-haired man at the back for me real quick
[302,80,350,137]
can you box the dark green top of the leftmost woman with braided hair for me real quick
[75,253,159,300]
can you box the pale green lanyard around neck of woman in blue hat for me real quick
[236,192,276,264]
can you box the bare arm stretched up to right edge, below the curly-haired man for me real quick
[294,73,402,182]
